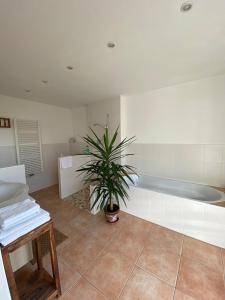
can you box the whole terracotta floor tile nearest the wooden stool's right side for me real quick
[60,233,104,273]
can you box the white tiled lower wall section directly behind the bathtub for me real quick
[129,144,225,187]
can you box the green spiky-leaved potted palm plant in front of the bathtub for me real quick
[77,127,136,223]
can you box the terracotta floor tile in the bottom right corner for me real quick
[177,257,225,300]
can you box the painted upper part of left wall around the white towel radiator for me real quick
[0,95,72,146]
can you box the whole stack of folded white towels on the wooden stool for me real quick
[0,199,50,246]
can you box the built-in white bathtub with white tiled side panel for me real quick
[118,176,225,248]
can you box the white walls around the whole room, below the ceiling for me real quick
[0,76,225,190]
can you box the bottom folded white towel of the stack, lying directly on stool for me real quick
[0,209,50,246]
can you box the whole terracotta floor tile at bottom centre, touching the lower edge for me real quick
[85,252,133,299]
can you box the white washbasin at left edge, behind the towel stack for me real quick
[0,181,29,207]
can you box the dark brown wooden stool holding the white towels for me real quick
[1,220,61,300]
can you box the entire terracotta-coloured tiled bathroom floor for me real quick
[29,187,225,300]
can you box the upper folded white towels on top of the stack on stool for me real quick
[0,199,40,229]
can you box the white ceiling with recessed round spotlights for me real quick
[0,0,225,107]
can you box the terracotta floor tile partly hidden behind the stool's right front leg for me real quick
[43,255,81,293]
